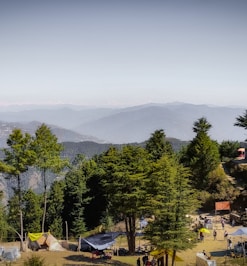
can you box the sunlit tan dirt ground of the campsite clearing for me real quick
[0,217,247,266]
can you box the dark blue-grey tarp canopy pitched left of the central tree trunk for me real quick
[82,232,121,250]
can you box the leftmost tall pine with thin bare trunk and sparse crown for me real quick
[3,129,35,250]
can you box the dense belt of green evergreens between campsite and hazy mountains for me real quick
[0,111,247,262]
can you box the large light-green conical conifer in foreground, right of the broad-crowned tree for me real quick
[145,155,198,265]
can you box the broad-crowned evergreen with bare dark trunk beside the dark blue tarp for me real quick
[101,145,148,253]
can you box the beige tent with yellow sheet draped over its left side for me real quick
[28,232,65,251]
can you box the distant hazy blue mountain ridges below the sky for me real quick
[0,103,246,144]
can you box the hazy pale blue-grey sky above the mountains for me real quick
[0,0,247,106]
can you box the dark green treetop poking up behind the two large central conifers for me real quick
[145,129,173,161]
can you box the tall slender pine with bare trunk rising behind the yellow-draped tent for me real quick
[33,124,68,232]
